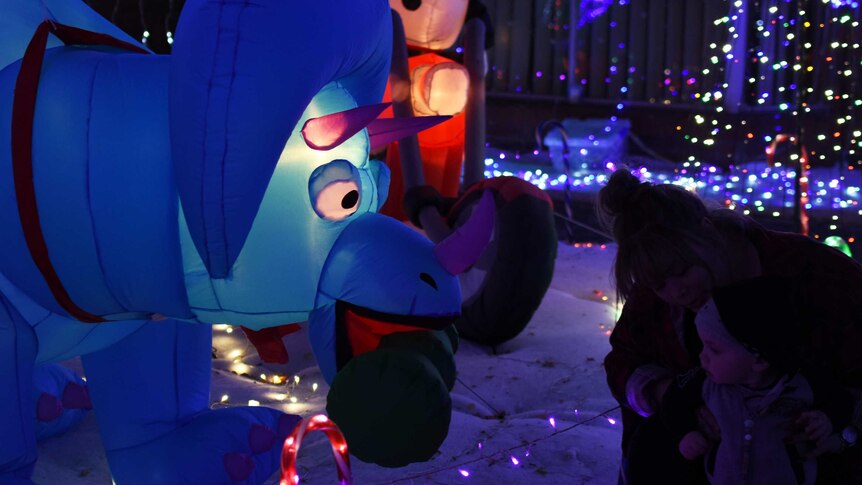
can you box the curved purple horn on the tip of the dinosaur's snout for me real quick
[434,190,497,275]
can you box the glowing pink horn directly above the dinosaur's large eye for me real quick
[302,103,391,150]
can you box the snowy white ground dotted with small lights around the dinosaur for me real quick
[34,243,622,485]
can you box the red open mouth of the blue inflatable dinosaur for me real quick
[335,300,458,369]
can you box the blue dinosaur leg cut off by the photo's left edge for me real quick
[0,294,38,484]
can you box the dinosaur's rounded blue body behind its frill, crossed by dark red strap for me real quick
[0,47,190,318]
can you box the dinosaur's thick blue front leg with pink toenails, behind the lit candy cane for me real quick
[83,320,299,485]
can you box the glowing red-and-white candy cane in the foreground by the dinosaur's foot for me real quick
[279,414,353,485]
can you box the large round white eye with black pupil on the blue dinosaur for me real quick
[308,160,362,221]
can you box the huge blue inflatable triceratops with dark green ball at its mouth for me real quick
[0,0,494,484]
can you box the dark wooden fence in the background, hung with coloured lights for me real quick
[485,0,862,109]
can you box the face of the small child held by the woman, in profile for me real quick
[695,299,757,384]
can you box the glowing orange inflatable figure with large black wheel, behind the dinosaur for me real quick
[383,0,557,345]
